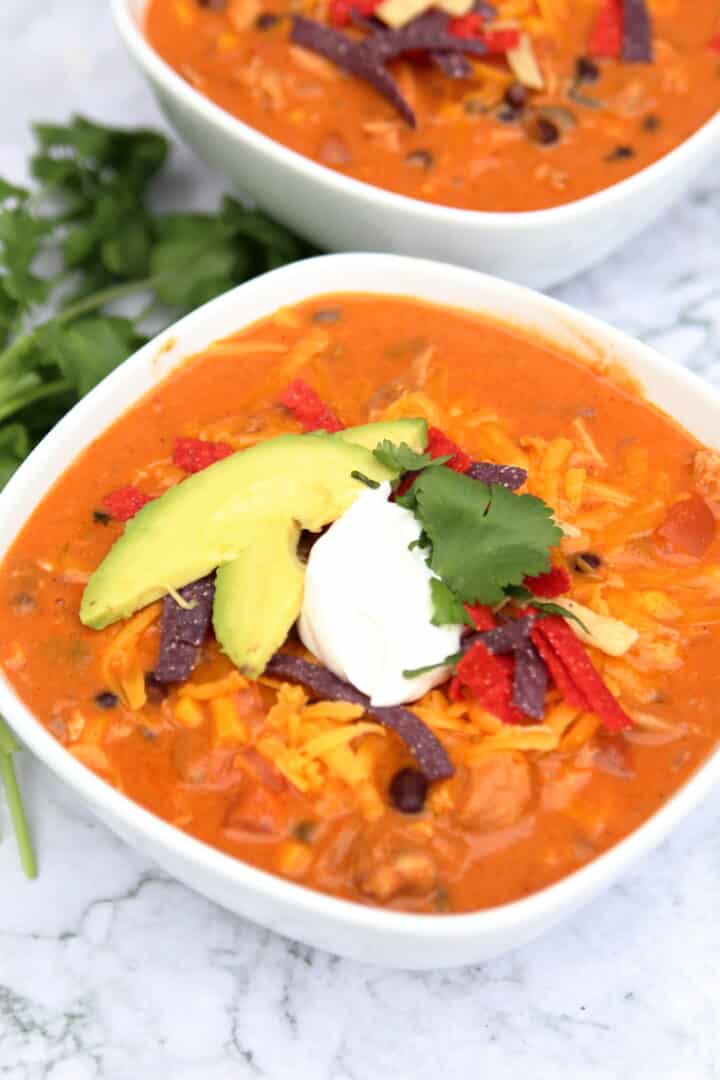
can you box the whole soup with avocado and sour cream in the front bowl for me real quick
[0,294,720,913]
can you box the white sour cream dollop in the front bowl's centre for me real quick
[299,484,462,705]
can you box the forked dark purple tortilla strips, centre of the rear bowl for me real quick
[290,11,487,127]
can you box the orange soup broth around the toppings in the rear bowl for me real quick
[146,0,720,211]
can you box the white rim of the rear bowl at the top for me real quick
[110,0,720,232]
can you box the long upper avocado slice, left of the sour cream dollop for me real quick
[80,435,393,630]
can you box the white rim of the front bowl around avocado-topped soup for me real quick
[0,253,720,944]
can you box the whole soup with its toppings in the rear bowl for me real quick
[146,0,720,211]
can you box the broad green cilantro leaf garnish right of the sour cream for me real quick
[412,469,562,604]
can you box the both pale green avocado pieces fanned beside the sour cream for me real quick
[80,421,426,648]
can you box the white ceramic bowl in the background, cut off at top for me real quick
[112,0,720,288]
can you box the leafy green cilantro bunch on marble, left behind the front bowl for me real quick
[0,117,309,488]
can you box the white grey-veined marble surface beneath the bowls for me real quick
[0,0,720,1080]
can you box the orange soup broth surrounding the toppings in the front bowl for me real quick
[0,295,720,912]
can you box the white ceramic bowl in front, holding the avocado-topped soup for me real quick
[0,255,720,969]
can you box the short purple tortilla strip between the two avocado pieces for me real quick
[153,576,215,683]
